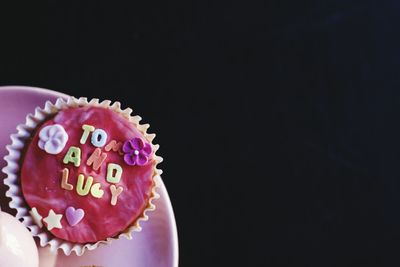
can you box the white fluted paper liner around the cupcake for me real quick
[3,97,162,256]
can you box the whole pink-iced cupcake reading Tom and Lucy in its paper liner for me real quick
[3,97,162,255]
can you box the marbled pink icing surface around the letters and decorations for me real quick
[21,107,155,243]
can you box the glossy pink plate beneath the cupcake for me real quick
[0,86,178,267]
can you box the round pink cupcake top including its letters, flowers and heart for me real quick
[20,106,156,243]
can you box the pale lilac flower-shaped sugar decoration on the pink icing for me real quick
[38,124,68,155]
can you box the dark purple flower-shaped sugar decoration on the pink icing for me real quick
[122,137,151,166]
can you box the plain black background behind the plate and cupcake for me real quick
[0,0,388,267]
